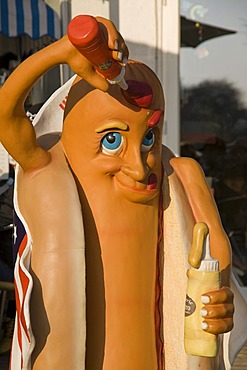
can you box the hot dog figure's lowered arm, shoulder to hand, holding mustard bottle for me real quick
[171,158,234,342]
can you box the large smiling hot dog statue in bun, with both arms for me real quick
[0,14,243,370]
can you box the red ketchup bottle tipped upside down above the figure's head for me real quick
[68,15,122,80]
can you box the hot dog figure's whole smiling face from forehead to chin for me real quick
[62,62,163,203]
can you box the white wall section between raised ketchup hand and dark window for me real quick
[119,0,180,154]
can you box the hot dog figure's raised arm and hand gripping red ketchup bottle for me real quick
[0,18,127,171]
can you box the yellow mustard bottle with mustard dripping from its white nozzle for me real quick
[184,222,221,357]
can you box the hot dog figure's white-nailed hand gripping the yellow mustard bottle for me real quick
[201,287,234,334]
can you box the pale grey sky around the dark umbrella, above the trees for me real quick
[180,0,247,103]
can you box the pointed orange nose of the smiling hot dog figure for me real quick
[121,155,149,181]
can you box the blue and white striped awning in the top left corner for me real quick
[0,0,61,40]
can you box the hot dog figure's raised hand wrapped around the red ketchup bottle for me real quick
[59,17,129,91]
